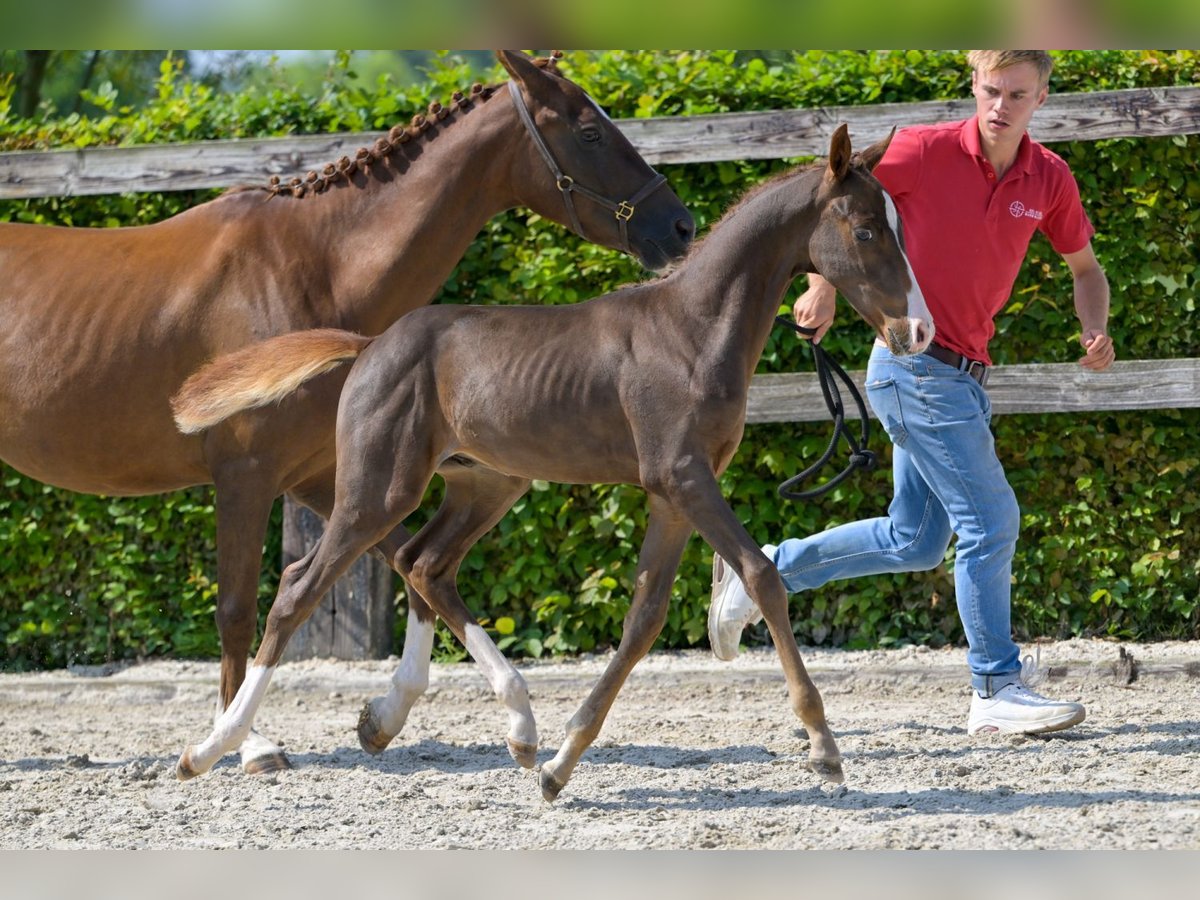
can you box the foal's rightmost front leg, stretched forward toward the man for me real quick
[684,478,845,782]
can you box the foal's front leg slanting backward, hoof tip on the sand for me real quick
[540,496,691,800]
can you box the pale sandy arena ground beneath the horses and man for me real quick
[0,641,1200,850]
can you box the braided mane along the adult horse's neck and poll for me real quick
[222,50,563,199]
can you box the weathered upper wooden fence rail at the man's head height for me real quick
[0,86,1200,200]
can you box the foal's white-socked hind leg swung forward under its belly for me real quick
[396,467,538,768]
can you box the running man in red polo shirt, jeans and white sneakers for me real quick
[708,50,1115,734]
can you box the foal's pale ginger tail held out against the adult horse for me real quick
[170,328,374,434]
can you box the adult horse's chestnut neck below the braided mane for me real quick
[285,98,523,334]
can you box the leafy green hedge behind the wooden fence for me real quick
[0,50,1200,668]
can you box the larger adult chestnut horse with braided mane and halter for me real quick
[0,52,694,772]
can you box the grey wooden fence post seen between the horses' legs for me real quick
[283,498,396,660]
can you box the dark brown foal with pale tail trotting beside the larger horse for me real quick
[173,126,934,800]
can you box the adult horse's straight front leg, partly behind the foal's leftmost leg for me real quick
[214,463,292,775]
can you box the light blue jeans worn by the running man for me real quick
[766,344,1021,696]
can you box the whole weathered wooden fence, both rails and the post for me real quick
[0,86,1200,659]
